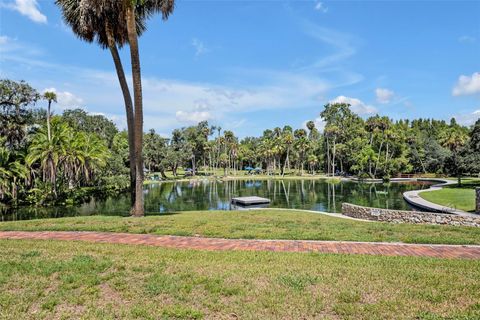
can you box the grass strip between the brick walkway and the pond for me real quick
[0,209,480,244]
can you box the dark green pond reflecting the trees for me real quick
[0,179,431,221]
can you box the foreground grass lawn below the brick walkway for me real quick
[0,240,480,319]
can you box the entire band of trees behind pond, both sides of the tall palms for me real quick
[0,80,480,204]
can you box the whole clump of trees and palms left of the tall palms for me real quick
[0,80,119,204]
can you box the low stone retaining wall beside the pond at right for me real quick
[342,203,480,227]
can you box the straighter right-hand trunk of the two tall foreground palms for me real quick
[127,5,144,216]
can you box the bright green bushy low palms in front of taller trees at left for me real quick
[0,117,110,204]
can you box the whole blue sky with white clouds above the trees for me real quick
[0,0,480,137]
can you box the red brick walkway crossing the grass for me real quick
[0,231,480,259]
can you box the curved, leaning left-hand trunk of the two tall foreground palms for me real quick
[107,27,136,210]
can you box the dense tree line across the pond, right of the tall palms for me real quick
[157,108,480,179]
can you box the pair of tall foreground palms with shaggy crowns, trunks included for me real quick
[56,0,174,216]
